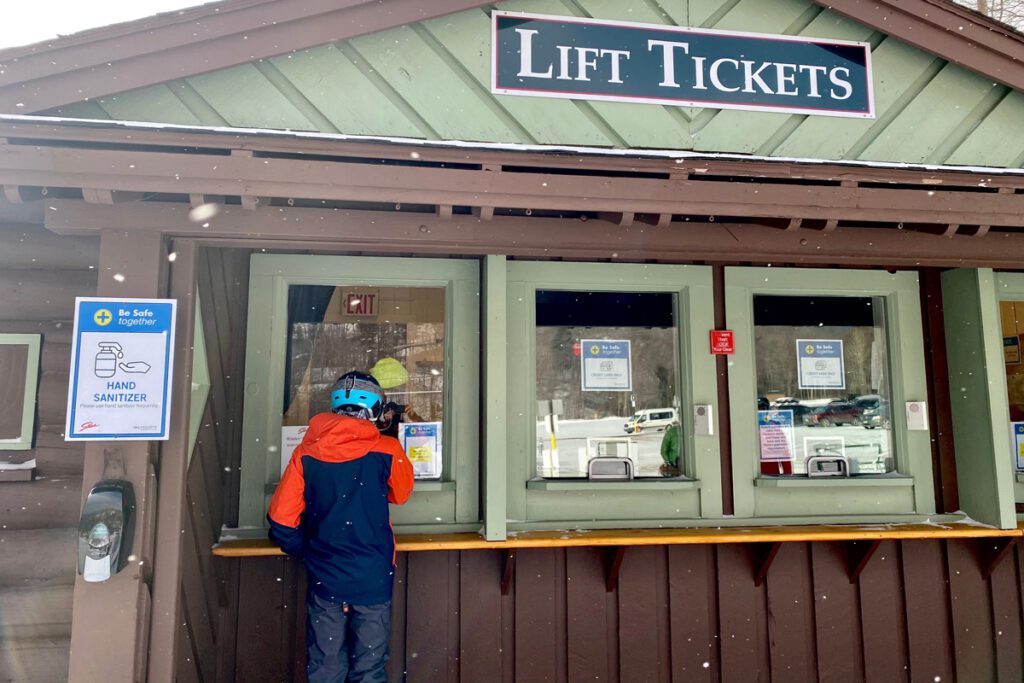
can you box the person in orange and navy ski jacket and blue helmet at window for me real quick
[267,373,413,682]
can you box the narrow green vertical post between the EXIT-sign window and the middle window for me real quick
[482,256,508,541]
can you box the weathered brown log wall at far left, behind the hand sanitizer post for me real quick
[0,222,99,683]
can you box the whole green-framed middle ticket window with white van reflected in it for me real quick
[505,261,722,529]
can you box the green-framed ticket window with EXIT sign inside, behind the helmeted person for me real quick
[239,254,480,531]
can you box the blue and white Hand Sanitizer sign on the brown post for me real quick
[65,297,177,441]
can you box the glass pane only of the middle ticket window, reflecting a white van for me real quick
[535,290,685,479]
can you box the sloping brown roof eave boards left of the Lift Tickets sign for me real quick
[0,0,487,114]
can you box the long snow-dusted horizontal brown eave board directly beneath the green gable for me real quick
[6,115,1024,190]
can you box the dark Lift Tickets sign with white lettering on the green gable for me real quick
[492,11,874,119]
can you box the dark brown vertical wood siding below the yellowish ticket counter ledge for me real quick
[222,541,1024,683]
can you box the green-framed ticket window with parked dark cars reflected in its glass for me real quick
[725,267,935,521]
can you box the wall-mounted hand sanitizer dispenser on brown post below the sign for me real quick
[78,479,135,583]
